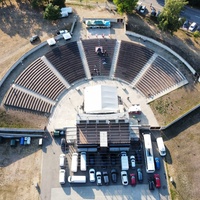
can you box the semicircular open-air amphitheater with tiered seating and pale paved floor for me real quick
[1,12,198,200]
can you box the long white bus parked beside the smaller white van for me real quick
[143,133,155,173]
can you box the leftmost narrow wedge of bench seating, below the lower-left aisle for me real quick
[4,87,53,113]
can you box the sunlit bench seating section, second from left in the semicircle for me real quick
[15,57,66,100]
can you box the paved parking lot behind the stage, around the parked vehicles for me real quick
[40,130,169,200]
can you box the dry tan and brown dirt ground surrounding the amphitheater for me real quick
[0,1,200,200]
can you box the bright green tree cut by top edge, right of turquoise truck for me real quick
[113,0,138,14]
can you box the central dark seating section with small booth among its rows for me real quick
[82,39,116,77]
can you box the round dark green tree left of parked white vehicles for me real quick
[43,3,61,20]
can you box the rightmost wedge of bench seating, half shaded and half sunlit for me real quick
[135,56,188,98]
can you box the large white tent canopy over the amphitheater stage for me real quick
[84,85,118,113]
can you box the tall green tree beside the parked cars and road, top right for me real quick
[158,0,188,34]
